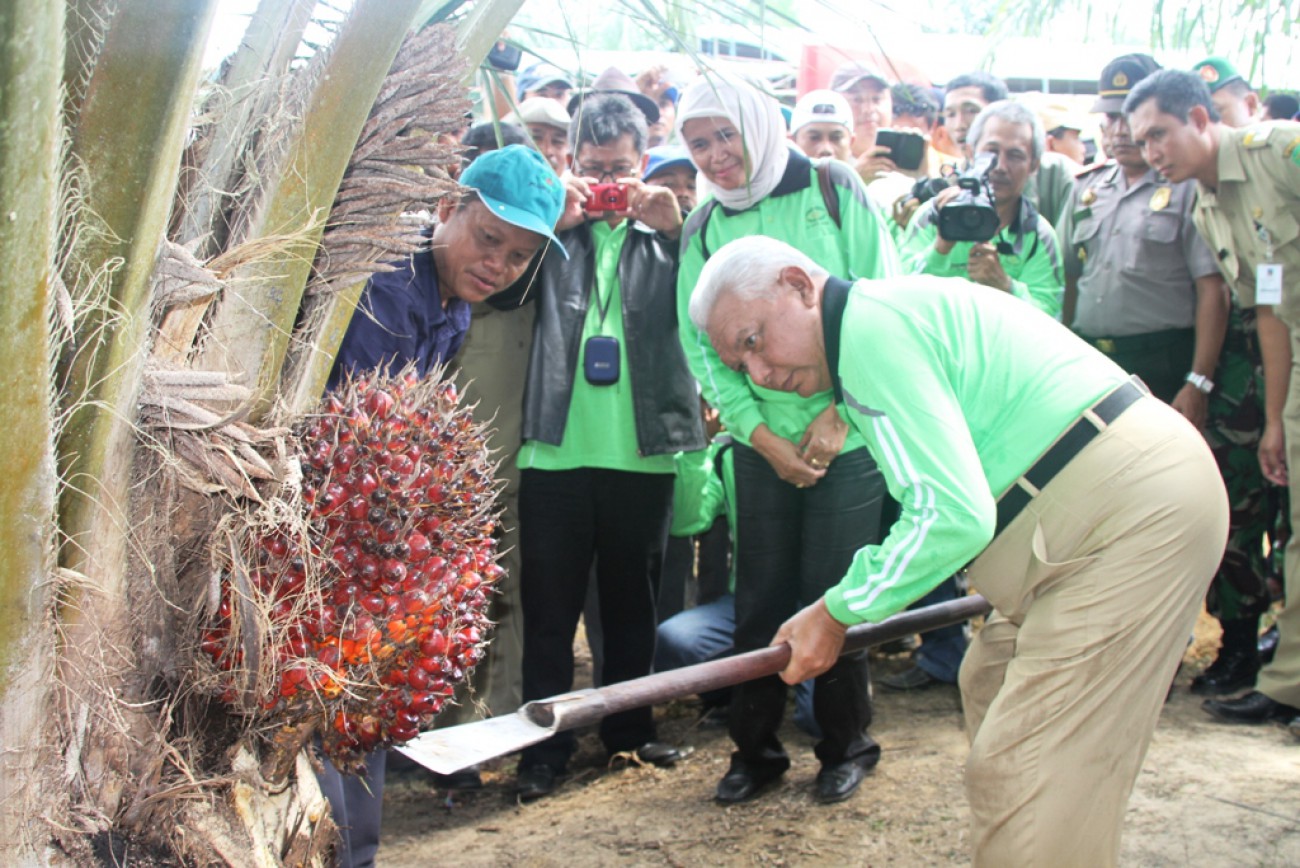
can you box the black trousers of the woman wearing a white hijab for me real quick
[729,443,888,765]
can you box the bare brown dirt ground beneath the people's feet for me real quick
[380,619,1300,868]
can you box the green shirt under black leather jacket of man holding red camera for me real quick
[519,220,675,473]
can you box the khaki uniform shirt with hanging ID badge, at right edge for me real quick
[1196,121,1300,329]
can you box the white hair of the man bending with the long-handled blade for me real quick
[690,235,827,331]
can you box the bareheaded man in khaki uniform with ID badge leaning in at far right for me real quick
[1125,70,1300,737]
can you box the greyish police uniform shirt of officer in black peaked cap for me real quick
[1061,162,1218,338]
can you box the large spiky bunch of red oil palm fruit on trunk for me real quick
[203,372,502,769]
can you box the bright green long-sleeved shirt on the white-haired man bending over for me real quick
[826,275,1128,624]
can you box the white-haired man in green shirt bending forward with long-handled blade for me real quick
[690,238,1229,865]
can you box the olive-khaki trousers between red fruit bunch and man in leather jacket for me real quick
[438,304,533,726]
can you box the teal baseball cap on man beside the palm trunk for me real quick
[460,144,568,259]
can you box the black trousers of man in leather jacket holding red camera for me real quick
[519,468,673,771]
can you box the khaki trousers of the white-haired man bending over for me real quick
[961,398,1229,868]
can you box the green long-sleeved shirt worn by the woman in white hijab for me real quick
[677,157,898,452]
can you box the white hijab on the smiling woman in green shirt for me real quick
[677,71,790,211]
